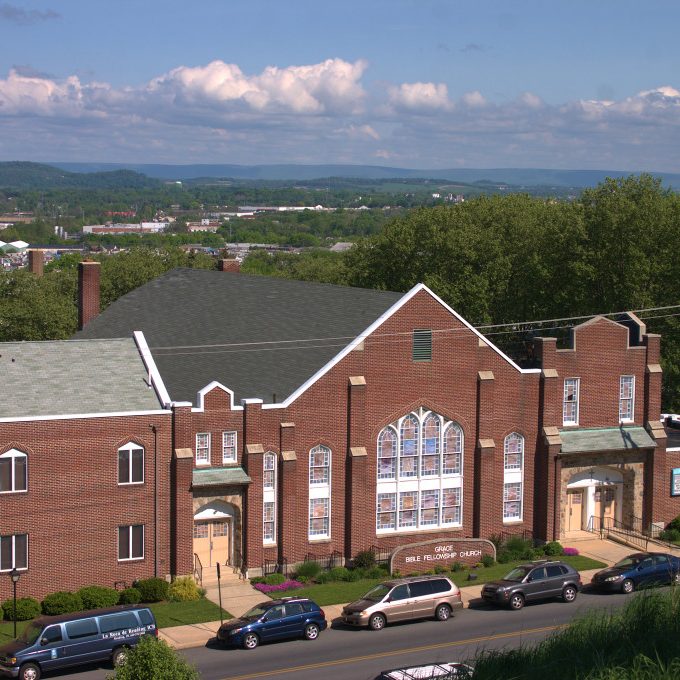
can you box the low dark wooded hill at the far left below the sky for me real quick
[0,161,161,190]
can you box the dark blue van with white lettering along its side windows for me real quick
[0,606,158,680]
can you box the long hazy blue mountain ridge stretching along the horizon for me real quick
[51,163,680,189]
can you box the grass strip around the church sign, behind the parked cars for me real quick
[286,555,607,607]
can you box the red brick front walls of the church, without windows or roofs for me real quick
[0,288,680,598]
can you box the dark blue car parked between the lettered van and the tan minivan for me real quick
[217,597,328,649]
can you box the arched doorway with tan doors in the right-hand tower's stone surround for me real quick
[564,467,623,533]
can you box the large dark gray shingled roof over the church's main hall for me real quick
[76,269,403,404]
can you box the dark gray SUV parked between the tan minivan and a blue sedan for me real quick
[482,560,583,609]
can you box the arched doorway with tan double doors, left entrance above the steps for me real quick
[194,500,235,567]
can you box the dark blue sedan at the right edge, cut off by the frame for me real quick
[591,553,680,593]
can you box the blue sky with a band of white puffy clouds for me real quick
[0,0,680,172]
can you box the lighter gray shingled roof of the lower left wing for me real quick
[0,337,162,418]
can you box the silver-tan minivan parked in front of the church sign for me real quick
[342,576,463,630]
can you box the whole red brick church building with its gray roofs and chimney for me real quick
[0,261,680,597]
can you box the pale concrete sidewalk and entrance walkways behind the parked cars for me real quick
[159,538,636,649]
